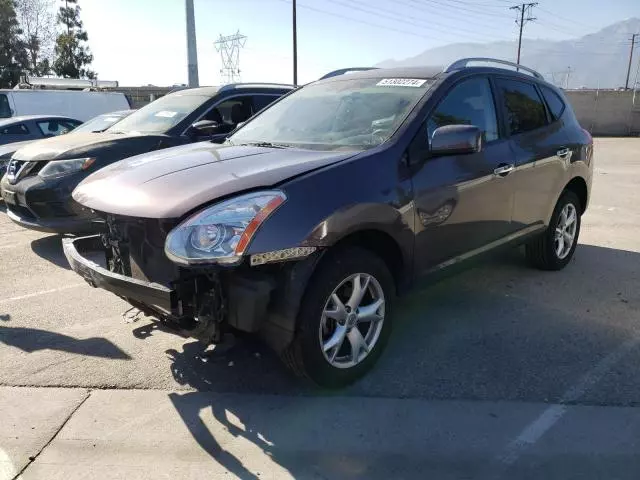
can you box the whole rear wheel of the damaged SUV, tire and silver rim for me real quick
[525,190,582,270]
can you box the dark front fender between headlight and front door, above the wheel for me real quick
[247,154,414,266]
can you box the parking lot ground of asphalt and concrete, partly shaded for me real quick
[0,138,640,479]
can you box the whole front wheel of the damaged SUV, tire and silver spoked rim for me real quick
[284,247,395,388]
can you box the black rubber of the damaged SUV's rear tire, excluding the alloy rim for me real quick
[525,190,582,270]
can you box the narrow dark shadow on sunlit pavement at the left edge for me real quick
[0,324,131,360]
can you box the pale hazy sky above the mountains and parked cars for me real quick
[74,0,640,85]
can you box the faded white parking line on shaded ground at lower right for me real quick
[498,336,640,466]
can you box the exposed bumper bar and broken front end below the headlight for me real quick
[63,215,315,350]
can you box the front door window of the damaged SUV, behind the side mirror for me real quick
[427,78,498,142]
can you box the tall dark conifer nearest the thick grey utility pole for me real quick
[53,0,96,78]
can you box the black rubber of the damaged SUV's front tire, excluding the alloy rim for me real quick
[283,247,395,388]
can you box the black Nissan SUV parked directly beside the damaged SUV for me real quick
[0,84,293,233]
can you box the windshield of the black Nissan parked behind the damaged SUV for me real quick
[107,92,211,133]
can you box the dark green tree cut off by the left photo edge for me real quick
[0,0,29,88]
